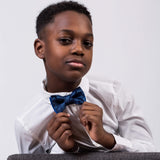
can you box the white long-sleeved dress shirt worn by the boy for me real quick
[15,77,155,153]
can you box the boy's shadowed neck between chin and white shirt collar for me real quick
[46,77,81,93]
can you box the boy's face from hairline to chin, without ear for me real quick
[35,11,93,82]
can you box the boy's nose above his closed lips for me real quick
[72,40,84,56]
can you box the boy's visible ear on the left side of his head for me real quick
[34,38,45,59]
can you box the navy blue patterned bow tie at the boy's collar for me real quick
[49,87,86,113]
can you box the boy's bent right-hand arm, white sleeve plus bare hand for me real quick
[80,94,155,152]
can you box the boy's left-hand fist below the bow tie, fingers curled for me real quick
[47,112,75,151]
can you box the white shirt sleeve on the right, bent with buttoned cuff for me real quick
[112,83,155,152]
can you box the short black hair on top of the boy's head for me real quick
[36,1,92,38]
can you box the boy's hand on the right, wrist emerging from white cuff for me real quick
[79,102,115,149]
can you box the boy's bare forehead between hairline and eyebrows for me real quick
[45,11,92,35]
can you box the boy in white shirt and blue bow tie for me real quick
[16,1,154,153]
